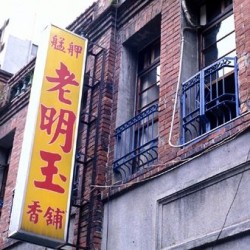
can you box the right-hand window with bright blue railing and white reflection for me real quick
[182,0,239,143]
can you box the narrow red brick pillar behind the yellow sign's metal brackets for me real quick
[71,11,115,249]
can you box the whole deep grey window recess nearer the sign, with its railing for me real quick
[114,16,160,180]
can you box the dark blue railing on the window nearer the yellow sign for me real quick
[114,104,158,179]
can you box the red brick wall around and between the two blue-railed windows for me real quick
[103,0,250,199]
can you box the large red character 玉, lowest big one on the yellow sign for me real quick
[34,151,67,193]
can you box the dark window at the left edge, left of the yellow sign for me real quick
[0,132,14,216]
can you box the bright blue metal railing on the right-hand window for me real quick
[181,57,239,143]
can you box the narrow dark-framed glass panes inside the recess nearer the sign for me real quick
[133,40,160,172]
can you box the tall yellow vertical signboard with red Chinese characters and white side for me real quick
[10,26,87,247]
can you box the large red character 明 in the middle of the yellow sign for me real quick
[40,105,76,153]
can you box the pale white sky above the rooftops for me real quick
[0,0,95,43]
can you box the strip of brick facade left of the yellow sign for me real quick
[0,61,34,248]
